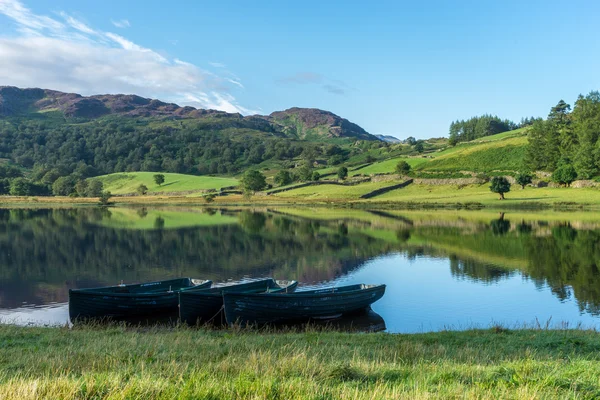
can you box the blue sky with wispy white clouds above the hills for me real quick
[0,0,600,138]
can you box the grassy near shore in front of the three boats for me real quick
[0,325,600,399]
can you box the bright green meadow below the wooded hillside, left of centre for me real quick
[94,172,239,194]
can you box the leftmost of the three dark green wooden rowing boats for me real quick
[69,278,212,322]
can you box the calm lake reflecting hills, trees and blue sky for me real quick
[0,207,600,332]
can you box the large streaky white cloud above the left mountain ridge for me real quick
[0,0,255,114]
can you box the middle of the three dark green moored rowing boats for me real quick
[179,278,298,325]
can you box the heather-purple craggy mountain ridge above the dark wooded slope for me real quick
[0,86,377,140]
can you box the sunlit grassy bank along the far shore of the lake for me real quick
[0,182,600,210]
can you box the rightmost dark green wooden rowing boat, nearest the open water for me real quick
[223,284,385,325]
